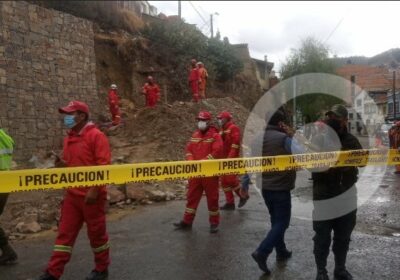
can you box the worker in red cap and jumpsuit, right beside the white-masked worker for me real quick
[217,111,249,210]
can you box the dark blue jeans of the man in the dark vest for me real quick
[257,190,292,256]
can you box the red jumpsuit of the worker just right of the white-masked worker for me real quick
[220,121,240,204]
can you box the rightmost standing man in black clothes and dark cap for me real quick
[313,104,362,280]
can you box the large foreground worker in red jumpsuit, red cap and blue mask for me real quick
[38,101,111,280]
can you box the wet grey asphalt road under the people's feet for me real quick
[0,167,400,280]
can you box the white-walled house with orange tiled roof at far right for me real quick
[337,64,400,133]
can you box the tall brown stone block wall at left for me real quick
[0,1,100,160]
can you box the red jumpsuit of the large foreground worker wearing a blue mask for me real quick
[47,123,111,279]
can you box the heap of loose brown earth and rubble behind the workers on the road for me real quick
[106,97,249,163]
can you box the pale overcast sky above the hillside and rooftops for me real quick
[149,1,400,71]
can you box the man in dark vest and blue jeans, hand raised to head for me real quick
[252,110,299,274]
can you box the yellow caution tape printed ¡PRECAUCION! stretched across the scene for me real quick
[0,149,400,193]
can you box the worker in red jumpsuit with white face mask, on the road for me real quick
[174,111,223,233]
